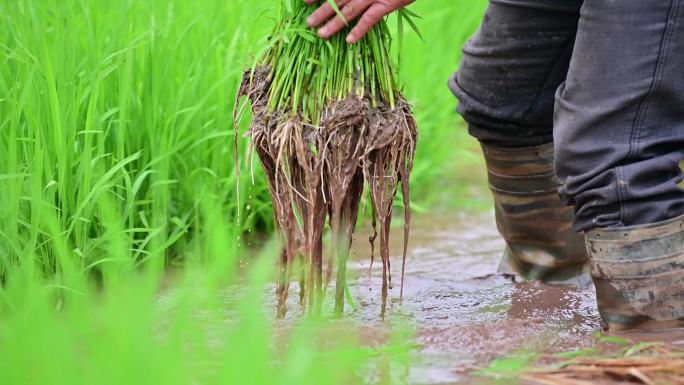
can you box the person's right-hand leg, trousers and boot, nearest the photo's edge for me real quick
[555,0,684,329]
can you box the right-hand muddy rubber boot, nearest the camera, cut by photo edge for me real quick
[587,216,684,331]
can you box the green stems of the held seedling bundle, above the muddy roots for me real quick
[258,0,399,119]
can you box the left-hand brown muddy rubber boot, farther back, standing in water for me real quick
[482,143,591,287]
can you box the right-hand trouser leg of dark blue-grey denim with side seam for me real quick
[554,0,684,231]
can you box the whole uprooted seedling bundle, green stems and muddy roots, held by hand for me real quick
[238,0,417,317]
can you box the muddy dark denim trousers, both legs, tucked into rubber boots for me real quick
[449,0,684,231]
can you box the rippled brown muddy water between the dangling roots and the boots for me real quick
[272,213,600,384]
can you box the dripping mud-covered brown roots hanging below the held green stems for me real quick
[238,66,417,317]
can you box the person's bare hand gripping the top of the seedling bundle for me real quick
[304,0,415,44]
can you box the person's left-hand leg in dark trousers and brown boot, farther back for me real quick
[449,0,589,285]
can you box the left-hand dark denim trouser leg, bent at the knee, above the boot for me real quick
[449,0,582,147]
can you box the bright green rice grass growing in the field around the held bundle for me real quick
[0,0,485,384]
